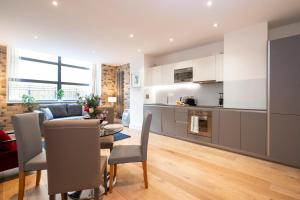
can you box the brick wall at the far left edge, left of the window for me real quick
[0,45,24,130]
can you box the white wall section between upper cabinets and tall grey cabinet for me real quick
[223,22,268,109]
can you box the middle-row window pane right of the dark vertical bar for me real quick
[61,66,92,84]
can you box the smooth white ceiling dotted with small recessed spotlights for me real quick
[0,0,300,63]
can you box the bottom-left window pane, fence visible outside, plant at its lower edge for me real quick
[9,81,57,101]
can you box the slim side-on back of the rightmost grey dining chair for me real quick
[141,113,152,160]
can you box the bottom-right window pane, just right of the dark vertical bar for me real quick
[62,85,91,100]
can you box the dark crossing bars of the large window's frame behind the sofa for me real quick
[7,56,92,103]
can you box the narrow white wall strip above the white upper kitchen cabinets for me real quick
[154,41,224,65]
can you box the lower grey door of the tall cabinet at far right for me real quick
[270,114,300,167]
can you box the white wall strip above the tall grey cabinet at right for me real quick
[269,22,300,40]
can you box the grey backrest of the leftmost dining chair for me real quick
[12,112,42,170]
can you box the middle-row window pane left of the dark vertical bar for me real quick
[12,60,58,81]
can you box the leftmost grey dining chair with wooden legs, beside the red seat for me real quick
[12,113,47,200]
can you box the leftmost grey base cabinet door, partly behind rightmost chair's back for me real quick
[144,106,162,134]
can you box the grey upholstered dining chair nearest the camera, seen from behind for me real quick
[44,119,107,200]
